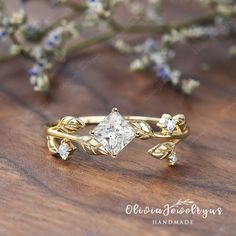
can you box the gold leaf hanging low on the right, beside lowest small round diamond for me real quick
[148,142,175,159]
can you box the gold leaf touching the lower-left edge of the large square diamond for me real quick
[79,136,109,155]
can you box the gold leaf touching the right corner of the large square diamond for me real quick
[130,121,153,139]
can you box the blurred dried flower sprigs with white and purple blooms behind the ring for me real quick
[0,0,236,95]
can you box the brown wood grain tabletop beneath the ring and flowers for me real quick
[0,1,236,236]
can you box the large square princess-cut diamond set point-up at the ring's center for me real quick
[91,109,135,156]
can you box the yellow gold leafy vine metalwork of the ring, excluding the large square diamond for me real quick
[46,108,190,166]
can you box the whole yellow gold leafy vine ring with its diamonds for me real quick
[47,108,190,166]
